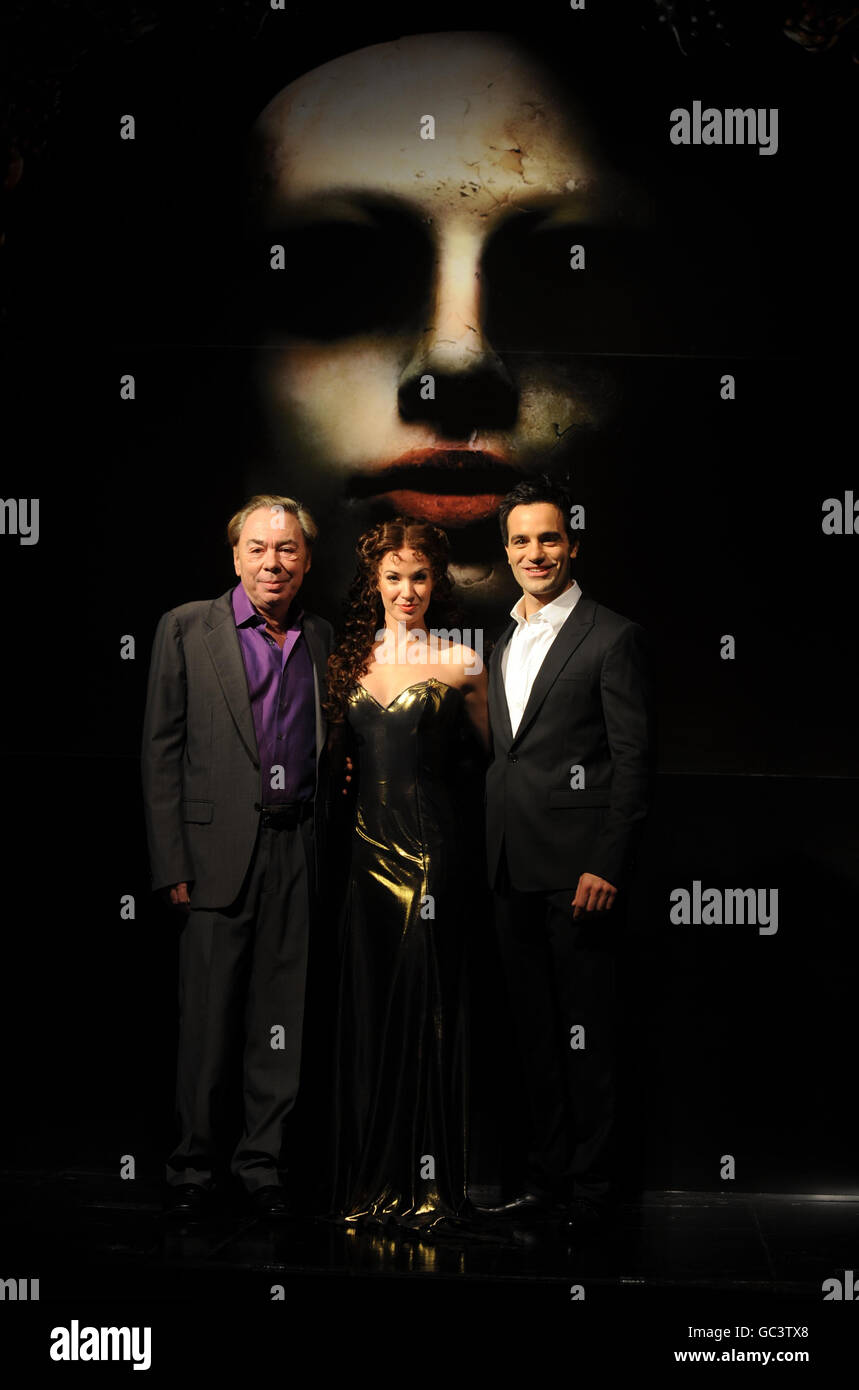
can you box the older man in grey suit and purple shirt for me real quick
[142,495,332,1218]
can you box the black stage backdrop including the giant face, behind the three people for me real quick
[0,3,859,1191]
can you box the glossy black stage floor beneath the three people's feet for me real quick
[0,1169,859,1300]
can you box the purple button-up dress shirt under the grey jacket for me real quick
[232,582,316,806]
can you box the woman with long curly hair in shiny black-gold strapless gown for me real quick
[322,517,488,1233]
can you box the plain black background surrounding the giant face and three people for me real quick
[0,4,859,1191]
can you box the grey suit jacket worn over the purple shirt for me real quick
[142,589,332,908]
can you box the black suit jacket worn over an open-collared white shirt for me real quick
[486,594,652,891]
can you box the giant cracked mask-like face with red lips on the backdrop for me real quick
[256,33,625,608]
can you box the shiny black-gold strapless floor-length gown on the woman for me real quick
[332,678,467,1230]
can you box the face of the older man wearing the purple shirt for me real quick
[232,507,310,616]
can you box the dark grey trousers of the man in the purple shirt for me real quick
[167,817,313,1191]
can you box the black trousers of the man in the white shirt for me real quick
[495,852,624,1201]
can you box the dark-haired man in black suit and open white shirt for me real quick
[486,478,651,1232]
